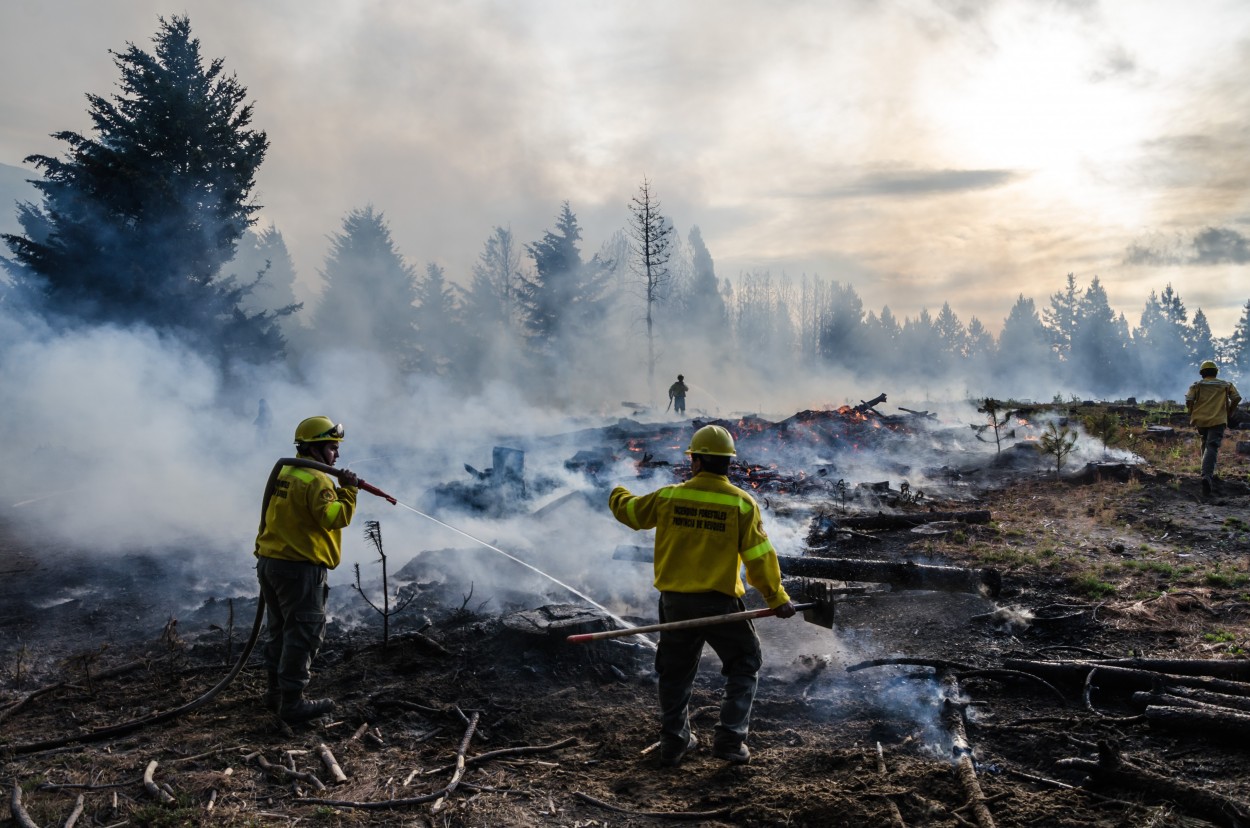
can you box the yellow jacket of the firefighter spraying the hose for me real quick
[256,465,356,569]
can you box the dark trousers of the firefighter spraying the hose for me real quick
[256,558,330,690]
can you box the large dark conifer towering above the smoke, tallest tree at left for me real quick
[5,16,283,360]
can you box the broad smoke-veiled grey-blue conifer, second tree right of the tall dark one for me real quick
[314,206,420,371]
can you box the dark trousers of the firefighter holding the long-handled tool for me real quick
[655,592,764,749]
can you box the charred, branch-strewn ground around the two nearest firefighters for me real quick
[0,425,1250,828]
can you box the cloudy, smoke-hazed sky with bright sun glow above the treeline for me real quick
[0,0,1250,335]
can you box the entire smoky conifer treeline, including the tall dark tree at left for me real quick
[0,16,1250,401]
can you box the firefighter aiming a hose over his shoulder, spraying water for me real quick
[255,417,358,722]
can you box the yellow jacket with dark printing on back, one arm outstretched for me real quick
[608,472,790,609]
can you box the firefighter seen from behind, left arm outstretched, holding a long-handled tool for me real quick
[609,425,795,767]
